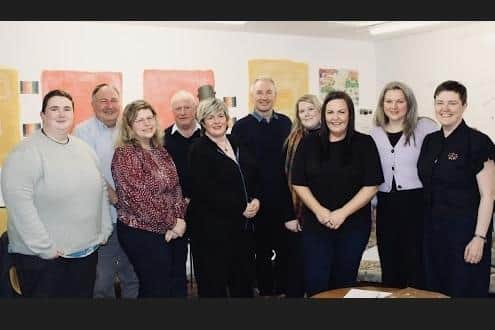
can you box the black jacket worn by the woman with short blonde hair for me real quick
[188,135,263,240]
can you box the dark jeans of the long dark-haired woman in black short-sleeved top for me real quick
[302,219,371,296]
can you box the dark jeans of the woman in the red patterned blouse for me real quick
[117,221,187,298]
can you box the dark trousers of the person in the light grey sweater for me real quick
[12,251,98,298]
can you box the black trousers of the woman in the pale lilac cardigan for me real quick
[376,189,425,289]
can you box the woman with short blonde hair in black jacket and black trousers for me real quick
[188,98,260,297]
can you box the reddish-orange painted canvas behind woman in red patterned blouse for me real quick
[143,70,215,129]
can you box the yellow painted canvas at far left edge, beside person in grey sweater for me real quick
[0,67,21,232]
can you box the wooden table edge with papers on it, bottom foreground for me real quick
[311,286,449,298]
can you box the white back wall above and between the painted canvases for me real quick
[0,22,376,131]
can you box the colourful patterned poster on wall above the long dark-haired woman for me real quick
[318,69,359,109]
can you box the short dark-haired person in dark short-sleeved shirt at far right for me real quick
[418,81,495,297]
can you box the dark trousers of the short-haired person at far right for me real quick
[425,216,492,298]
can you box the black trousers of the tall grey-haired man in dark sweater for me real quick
[254,208,288,296]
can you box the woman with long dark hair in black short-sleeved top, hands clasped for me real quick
[292,91,383,296]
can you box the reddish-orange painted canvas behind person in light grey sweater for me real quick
[41,70,122,131]
